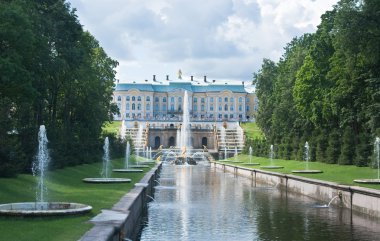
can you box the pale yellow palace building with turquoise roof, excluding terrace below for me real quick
[113,75,257,122]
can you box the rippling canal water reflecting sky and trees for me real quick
[140,166,380,241]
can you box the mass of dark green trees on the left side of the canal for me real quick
[0,0,117,176]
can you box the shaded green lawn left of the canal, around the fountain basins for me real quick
[0,159,153,241]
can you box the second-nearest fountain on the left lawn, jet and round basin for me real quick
[83,137,131,183]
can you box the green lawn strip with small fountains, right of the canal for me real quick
[218,155,380,190]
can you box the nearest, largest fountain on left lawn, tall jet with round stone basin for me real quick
[0,125,92,216]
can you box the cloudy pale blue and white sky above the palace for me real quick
[69,0,337,82]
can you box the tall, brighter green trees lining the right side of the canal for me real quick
[253,0,380,166]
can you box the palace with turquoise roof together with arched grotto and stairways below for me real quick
[113,75,257,153]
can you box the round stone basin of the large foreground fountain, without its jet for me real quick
[0,202,92,216]
